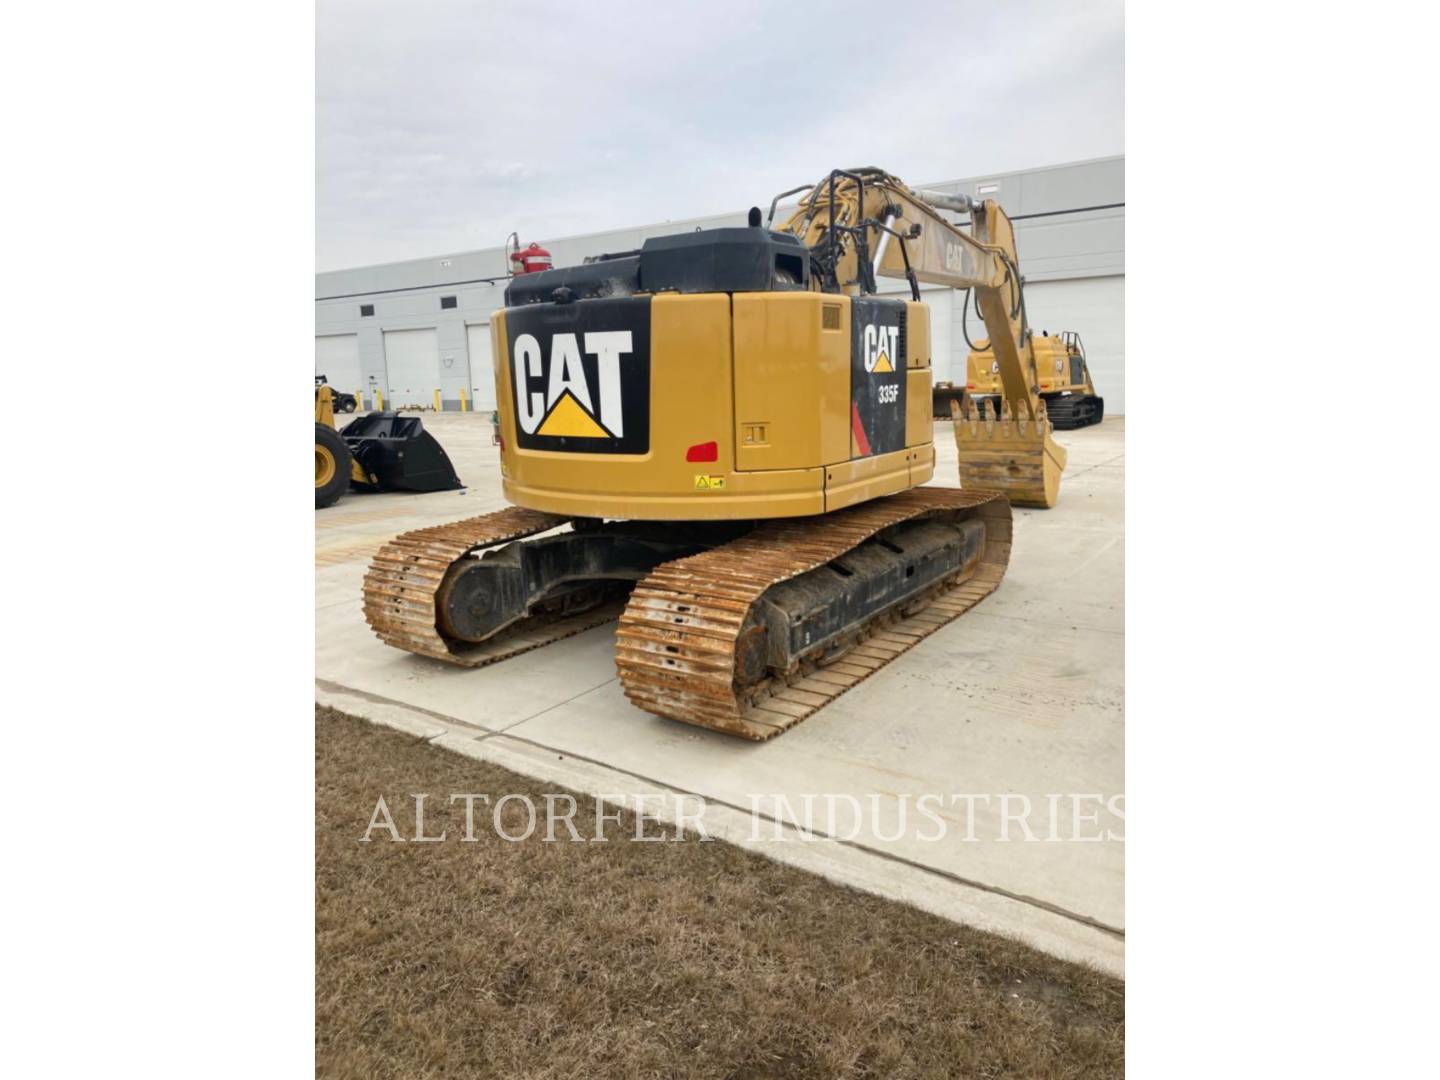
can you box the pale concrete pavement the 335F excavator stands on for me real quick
[315,413,1125,973]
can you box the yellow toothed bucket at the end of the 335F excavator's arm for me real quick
[950,402,1066,510]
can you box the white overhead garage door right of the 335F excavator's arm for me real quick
[1025,275,1125,416]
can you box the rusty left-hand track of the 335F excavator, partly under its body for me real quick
[364,507,624,668]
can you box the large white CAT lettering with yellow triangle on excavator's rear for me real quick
[513,330,635,439]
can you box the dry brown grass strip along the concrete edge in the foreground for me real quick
[315,708,1125,1080]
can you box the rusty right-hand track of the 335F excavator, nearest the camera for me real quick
[615,488,1011,740]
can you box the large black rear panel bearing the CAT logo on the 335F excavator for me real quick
[505,297,649,454]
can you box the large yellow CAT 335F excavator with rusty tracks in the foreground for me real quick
[364,168,1064,739]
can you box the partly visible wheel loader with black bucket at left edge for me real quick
[315,376,464,510]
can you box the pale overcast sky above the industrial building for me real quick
[315,0,1125,269]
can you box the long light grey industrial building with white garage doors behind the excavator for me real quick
[315,157,1125,416]
